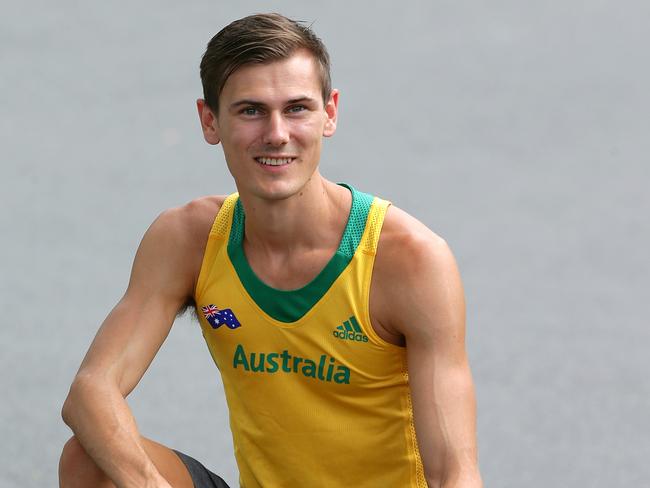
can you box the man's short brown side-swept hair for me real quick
[201,13,332,114]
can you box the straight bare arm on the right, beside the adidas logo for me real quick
[378,209,482,488]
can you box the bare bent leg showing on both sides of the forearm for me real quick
[59,436,194,488]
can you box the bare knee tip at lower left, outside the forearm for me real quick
[59,436,114,488]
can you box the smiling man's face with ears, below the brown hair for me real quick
[198,52,338,200]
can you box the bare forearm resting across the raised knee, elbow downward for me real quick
[62,377,165,488]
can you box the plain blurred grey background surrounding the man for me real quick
[0,0,650,488]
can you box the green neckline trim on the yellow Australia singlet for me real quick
[228,183,373,323]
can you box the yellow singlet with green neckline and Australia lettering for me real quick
[195,185,427,488]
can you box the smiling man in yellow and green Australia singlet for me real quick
[60,14,481,488]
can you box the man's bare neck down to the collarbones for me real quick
[240,177,351,256]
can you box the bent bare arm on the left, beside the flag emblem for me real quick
[62,199,209,487]
